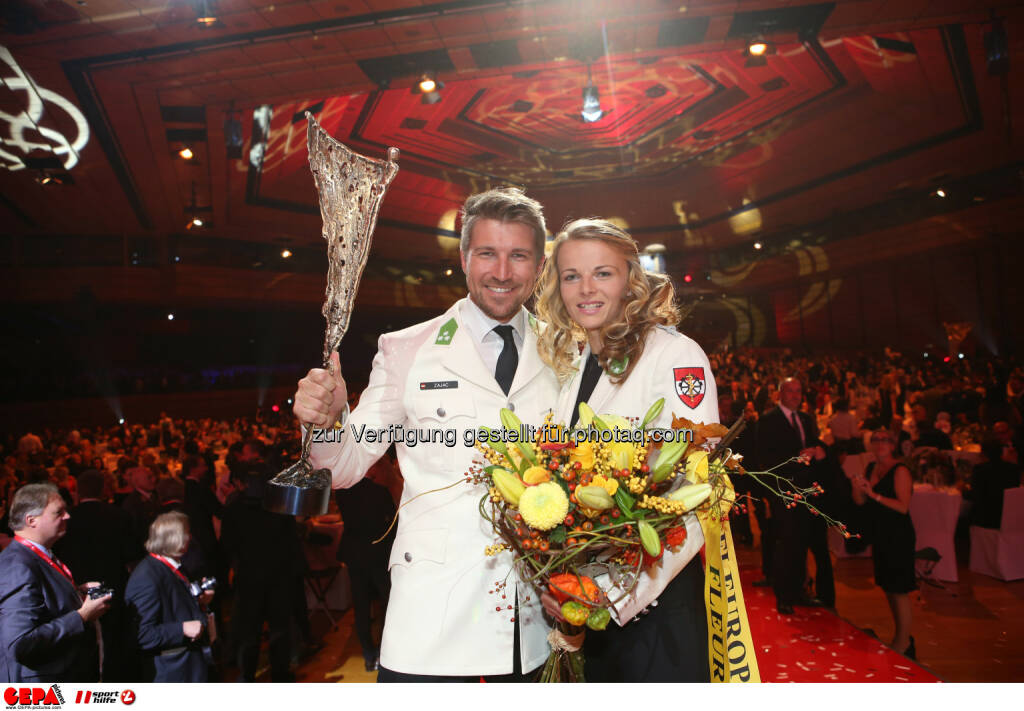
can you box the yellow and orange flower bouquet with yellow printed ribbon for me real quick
[468,400,835,681]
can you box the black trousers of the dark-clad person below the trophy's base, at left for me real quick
[234,577,295,681]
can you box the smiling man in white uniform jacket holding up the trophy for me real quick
[294,189,558,681]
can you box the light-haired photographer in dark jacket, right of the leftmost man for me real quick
[125,511,213,682]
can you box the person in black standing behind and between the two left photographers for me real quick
[55,469,145,681]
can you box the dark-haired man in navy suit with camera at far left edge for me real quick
[0,484,111,682]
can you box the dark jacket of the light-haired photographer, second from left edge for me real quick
[125,555,208,681]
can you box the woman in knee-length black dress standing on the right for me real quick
[853,429,918,659]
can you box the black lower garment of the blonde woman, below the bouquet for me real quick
[584,555,711,682]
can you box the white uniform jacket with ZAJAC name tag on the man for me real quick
[310,301,558,675]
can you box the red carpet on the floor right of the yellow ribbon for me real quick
[740,567,941,682]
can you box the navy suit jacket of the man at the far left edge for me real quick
[0,541,99,682]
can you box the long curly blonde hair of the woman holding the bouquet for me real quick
[535,217,680,383]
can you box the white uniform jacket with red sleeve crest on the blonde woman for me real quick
[555,327,719,625]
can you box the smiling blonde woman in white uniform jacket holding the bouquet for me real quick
[537,219,718,681]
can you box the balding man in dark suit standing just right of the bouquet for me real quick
[755,378,836,615]
